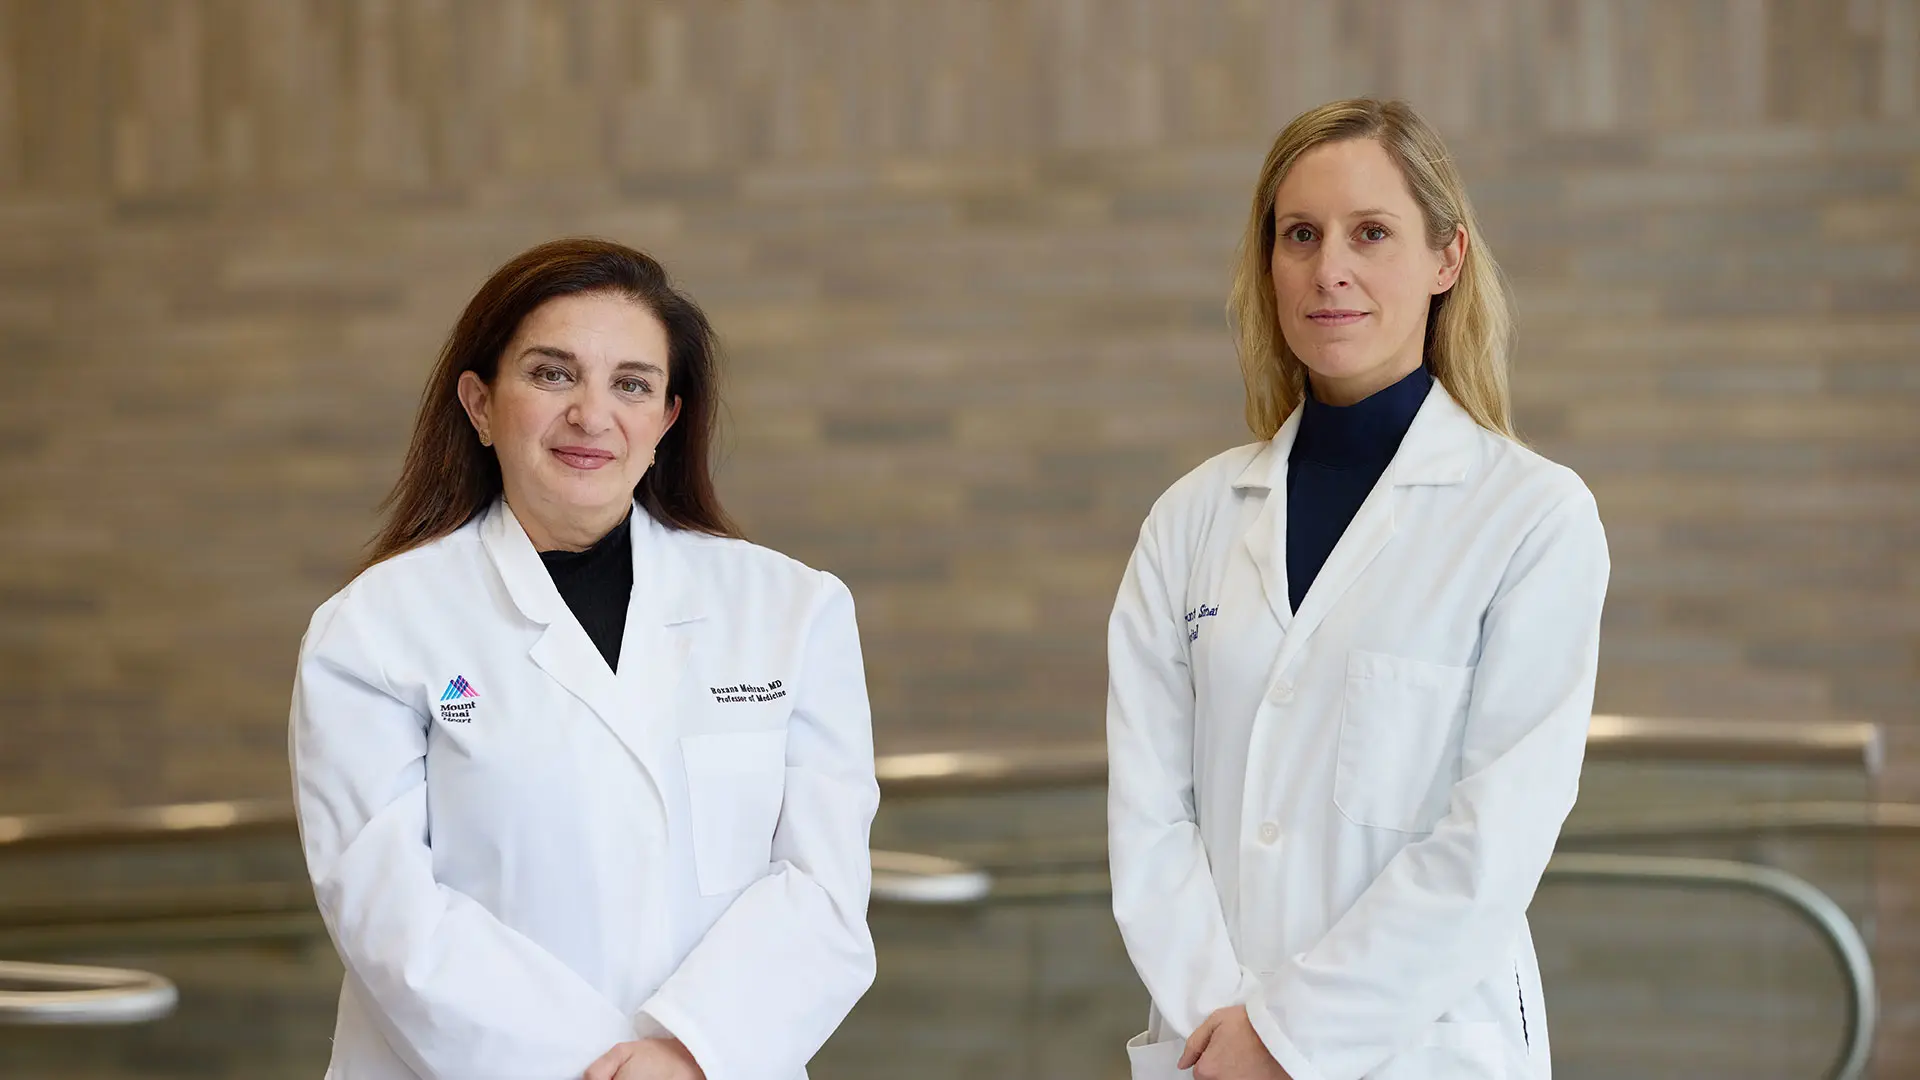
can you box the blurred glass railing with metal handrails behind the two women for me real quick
[0,717,1889,1080]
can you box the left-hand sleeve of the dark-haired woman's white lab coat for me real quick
[290,598,636,1080]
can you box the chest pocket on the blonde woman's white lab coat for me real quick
[1332,650,1473,832]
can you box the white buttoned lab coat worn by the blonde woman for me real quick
[1108,382,1609,1080]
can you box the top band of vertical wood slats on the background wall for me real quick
[0,0,1920,194]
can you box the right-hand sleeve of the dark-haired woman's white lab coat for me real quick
[639,573,879,1080]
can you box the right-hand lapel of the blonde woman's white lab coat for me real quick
[1269,382,1476,671]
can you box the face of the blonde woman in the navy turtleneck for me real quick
[1273,138,1467,405]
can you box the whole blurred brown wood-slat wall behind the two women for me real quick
[0,0,1920,1076]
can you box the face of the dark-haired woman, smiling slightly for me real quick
[461,292,680,552]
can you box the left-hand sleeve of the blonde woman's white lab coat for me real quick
[1106,517,1254,1036]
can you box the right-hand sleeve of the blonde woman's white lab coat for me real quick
[1248,488,1609,1080]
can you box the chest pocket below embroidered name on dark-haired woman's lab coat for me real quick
[680,728,787,896]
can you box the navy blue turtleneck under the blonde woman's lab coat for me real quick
[1286,365,1432,611]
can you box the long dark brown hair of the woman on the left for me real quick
[365,238,741,567]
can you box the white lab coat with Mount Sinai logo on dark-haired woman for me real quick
[290,502,879,1080]
